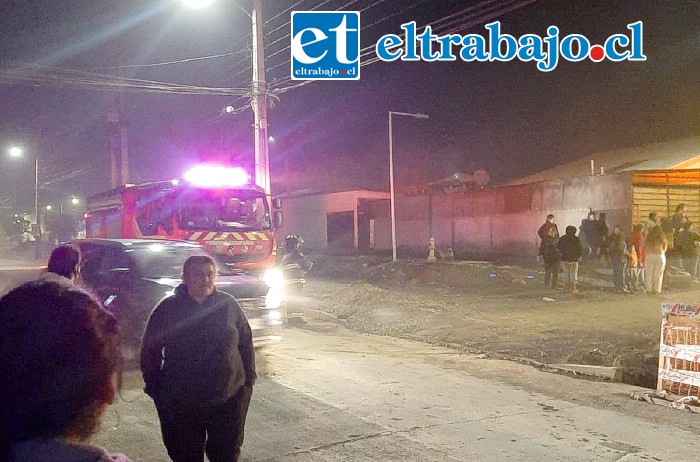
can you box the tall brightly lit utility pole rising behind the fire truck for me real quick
[251,0,270,196]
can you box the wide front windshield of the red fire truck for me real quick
[179,188,271,231]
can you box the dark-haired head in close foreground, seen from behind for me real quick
[0,279,129,462]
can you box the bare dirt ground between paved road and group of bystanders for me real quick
[306,255,700,388]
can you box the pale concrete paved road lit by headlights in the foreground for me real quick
[98,324,700,462]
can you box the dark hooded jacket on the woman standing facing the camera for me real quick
[141,284,257,405]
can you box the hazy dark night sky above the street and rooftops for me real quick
[0,0,700,211]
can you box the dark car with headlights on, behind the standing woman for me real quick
[73,239,283,361]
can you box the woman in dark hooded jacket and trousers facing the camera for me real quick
[141,255,257,462]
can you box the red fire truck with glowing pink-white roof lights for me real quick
[85,165,282,274]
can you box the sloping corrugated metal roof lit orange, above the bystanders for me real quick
[506,136,700,185]
